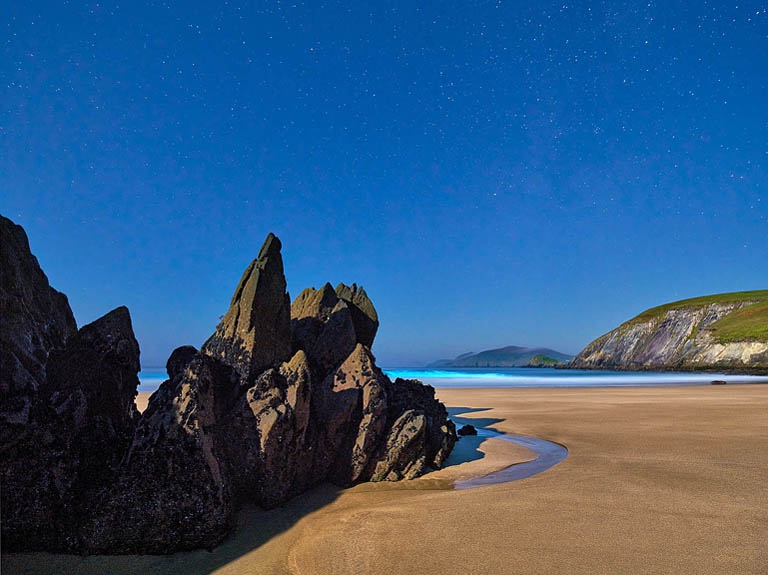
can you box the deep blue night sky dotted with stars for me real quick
[0,0,768,366]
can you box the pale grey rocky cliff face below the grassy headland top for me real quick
[569,292,768,372]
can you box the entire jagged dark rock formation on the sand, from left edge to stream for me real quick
[0,215,456,553]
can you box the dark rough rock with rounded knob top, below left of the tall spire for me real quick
[83,354,239,553]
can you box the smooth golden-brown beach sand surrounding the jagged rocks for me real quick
[2,385,768,575]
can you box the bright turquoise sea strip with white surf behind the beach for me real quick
[139,367,768,392]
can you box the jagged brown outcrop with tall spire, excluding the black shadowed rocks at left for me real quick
[101,236,456,552]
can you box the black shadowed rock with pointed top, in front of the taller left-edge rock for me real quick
[2,307,139,550]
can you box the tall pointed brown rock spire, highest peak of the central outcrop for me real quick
[201,234,291,382]
